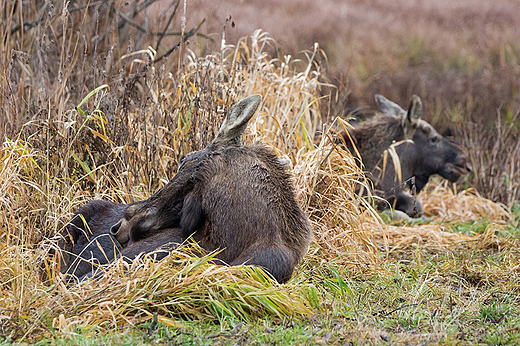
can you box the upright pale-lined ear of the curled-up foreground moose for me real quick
[213,95,262,144]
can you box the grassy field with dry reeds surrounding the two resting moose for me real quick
[0,0,520,345]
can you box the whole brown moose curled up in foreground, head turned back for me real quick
[55,95,312,282]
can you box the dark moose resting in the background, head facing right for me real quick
[340,95,471,217]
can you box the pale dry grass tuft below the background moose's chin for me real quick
[419,181,514,224]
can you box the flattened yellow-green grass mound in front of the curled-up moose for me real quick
[22,249,311,335]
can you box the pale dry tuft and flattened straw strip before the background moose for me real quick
[375,179,517,252]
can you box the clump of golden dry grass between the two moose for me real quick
[293,133,383,271]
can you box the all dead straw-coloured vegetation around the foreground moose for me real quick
[0,1,512,340]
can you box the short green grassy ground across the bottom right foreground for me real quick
[8,216,520,345]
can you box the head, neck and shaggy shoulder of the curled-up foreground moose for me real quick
[112,96,312,282]
